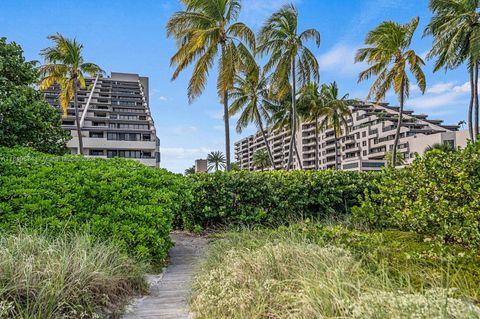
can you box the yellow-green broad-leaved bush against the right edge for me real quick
[354,142,480,248]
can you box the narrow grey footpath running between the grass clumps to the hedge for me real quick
[122,233,207,319]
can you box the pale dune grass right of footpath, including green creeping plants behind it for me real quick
[190,226,480,319]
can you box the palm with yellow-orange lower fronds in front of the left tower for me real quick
[39,33,103,155]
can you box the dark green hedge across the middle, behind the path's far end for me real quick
[176,171,376,229]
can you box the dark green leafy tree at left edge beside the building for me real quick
[0,38,70,154]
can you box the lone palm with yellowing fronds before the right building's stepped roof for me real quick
[355,17,426,167]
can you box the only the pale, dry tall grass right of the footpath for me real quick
[190,231,480,319]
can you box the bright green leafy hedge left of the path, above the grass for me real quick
[0,148,189,261]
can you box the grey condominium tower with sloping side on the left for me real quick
[45,72,160,167]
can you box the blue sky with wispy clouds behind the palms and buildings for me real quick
[0,0,469,172]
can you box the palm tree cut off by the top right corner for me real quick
[425,0,480,141]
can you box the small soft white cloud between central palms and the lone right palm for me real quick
[318,43,367,76]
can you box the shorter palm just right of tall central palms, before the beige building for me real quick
[320,82,354,169]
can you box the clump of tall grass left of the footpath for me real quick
[0,231,145,319]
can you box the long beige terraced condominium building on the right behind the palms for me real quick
[235,102,468,171]
